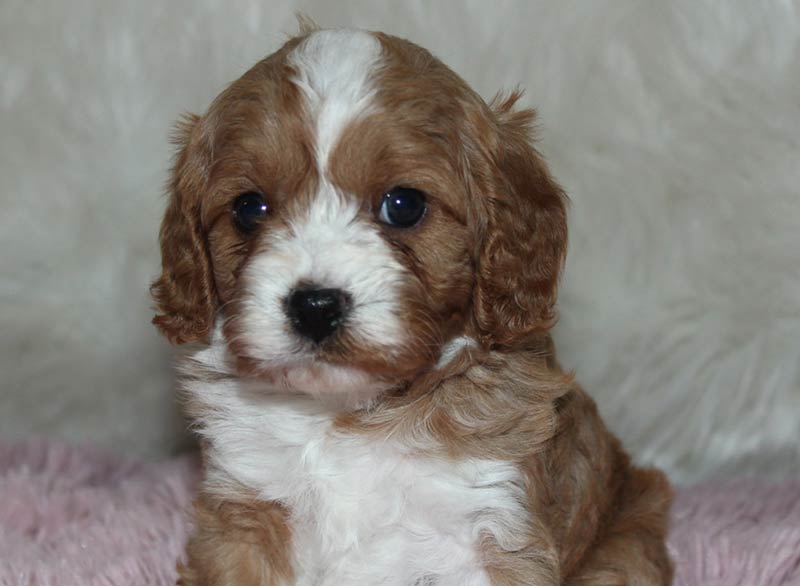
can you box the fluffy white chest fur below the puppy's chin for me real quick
[187,344,527,586]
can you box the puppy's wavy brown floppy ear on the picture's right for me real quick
[474,92,567,347]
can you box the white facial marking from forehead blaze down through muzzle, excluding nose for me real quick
[231,30,406,404]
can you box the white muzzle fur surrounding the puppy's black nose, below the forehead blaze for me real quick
[236,181,407,402]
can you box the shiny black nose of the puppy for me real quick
[286,289,347,342]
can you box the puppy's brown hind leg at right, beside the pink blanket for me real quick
[565,468,672,586]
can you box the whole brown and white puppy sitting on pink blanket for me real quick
[152,30,671,586]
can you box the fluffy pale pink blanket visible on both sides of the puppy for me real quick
[0,442,800,586]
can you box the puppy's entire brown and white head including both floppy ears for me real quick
[153,30,566,399]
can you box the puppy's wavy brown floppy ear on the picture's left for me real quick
[150,115,217,344]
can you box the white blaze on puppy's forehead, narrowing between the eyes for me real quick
[289,29,381,172]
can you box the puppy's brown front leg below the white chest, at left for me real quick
[178,496,292,586]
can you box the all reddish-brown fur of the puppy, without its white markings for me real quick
[153,30,671,586]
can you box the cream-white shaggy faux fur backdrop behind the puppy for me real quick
[0,0,800,480]
